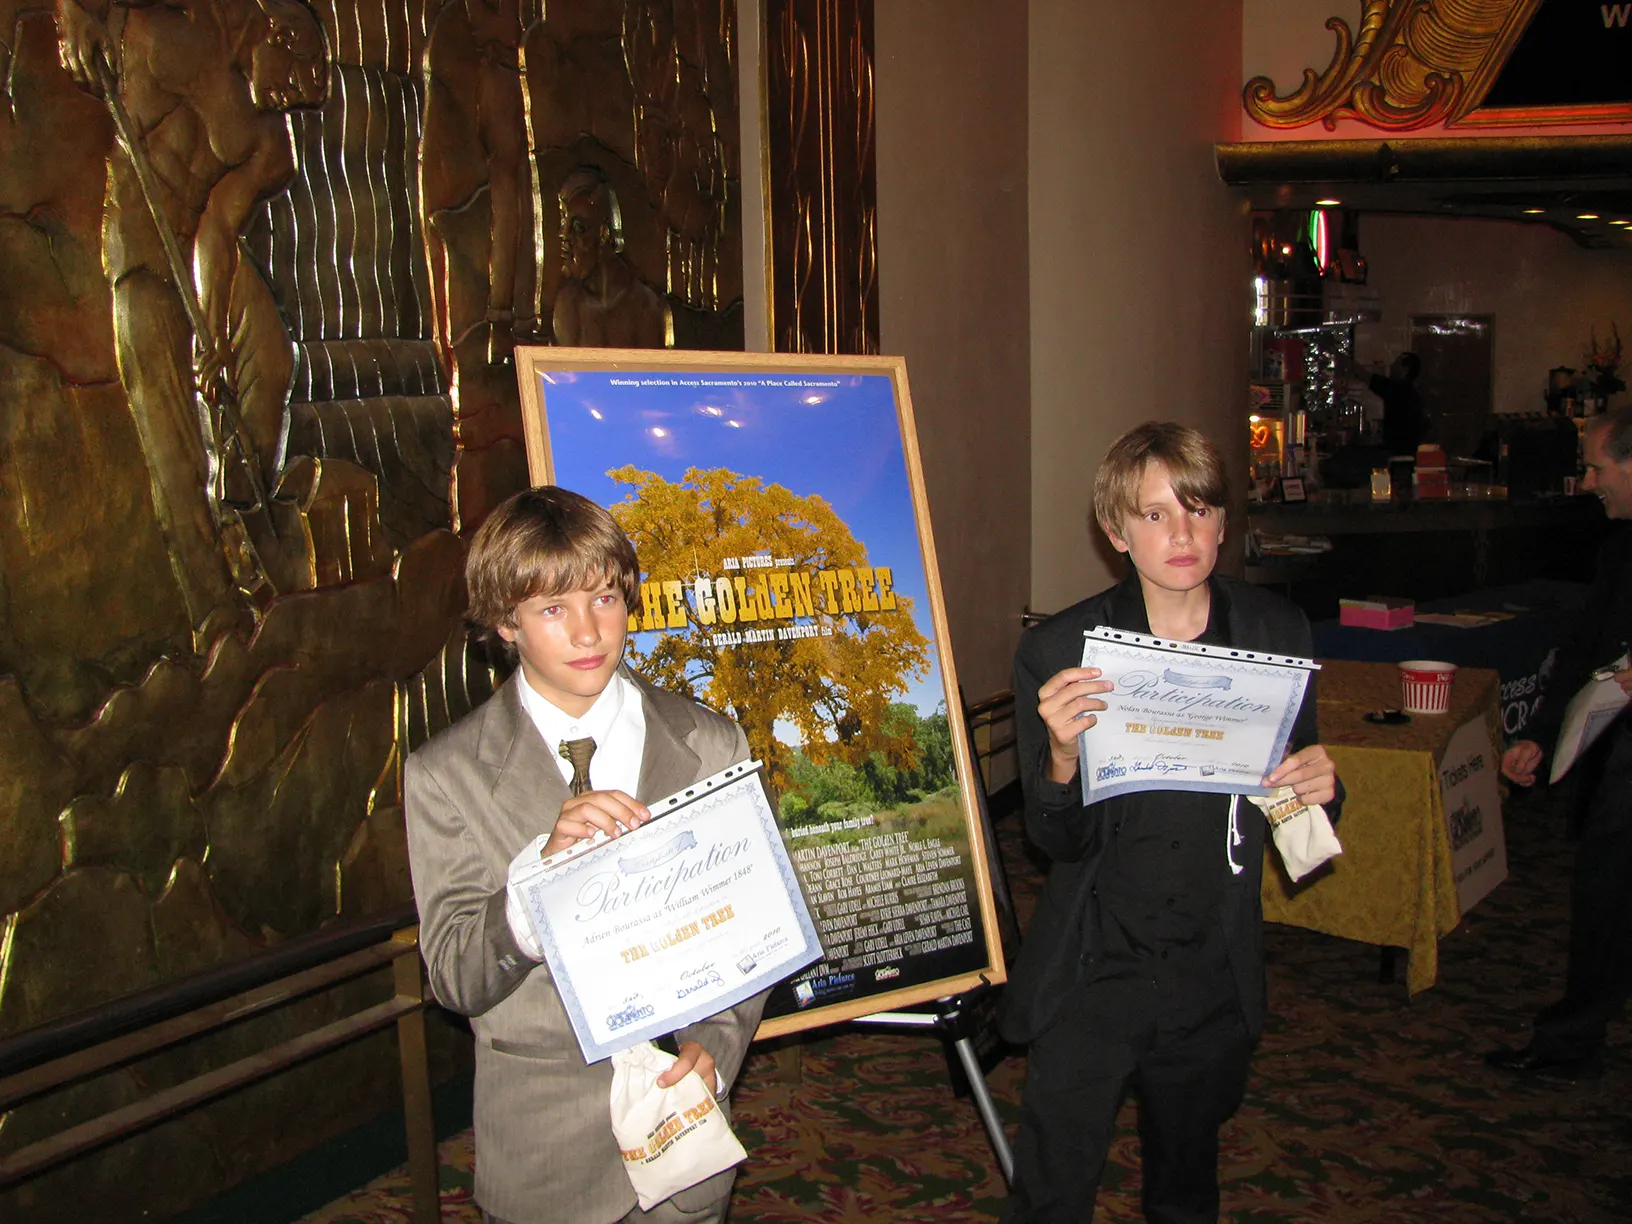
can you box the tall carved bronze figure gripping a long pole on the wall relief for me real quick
[57,0,328,630]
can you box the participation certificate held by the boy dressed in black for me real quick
[1077,625,1320,805]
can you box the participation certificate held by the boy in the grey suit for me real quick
[517,761,821,1062]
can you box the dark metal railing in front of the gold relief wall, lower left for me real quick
[0,904,441,1224]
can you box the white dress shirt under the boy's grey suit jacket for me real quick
[504,667,646,961]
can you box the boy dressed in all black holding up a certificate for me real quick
[1000,421,1342,1224]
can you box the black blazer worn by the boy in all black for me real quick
[1000,574,1343,1041]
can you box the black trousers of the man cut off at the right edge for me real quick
[1532,728,1632,1058]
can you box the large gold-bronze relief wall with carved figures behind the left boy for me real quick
[0,0,741,1221]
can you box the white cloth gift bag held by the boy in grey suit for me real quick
[612,1041,747,1211]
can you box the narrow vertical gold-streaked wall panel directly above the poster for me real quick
[764,0,878,353]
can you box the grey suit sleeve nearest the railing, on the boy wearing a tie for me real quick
[403,752,548,1015]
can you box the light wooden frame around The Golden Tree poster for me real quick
[516,346,1007,1038]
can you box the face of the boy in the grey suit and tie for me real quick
[499,583,628,718]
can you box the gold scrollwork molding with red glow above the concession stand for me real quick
[1242,0,1573,132]
